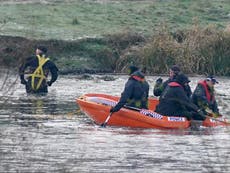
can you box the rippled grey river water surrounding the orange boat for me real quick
[0,73,230,173]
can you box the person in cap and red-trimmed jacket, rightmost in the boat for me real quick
[192,76,220,117]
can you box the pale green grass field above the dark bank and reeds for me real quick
[0,0,230,40]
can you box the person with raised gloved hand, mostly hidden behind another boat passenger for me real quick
[153,65,192,98]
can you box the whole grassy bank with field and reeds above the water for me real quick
[0,0,230,75]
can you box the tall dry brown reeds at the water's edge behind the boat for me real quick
[116,24,230,75]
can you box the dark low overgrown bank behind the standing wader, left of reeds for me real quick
[0,32,145,74]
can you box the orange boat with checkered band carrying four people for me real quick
[76,93,229,129]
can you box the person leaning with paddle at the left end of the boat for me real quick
[110,71,149,112]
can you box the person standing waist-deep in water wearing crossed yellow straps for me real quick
[19,46,58,93]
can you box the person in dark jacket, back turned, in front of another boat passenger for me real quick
[155,73,203,120]
